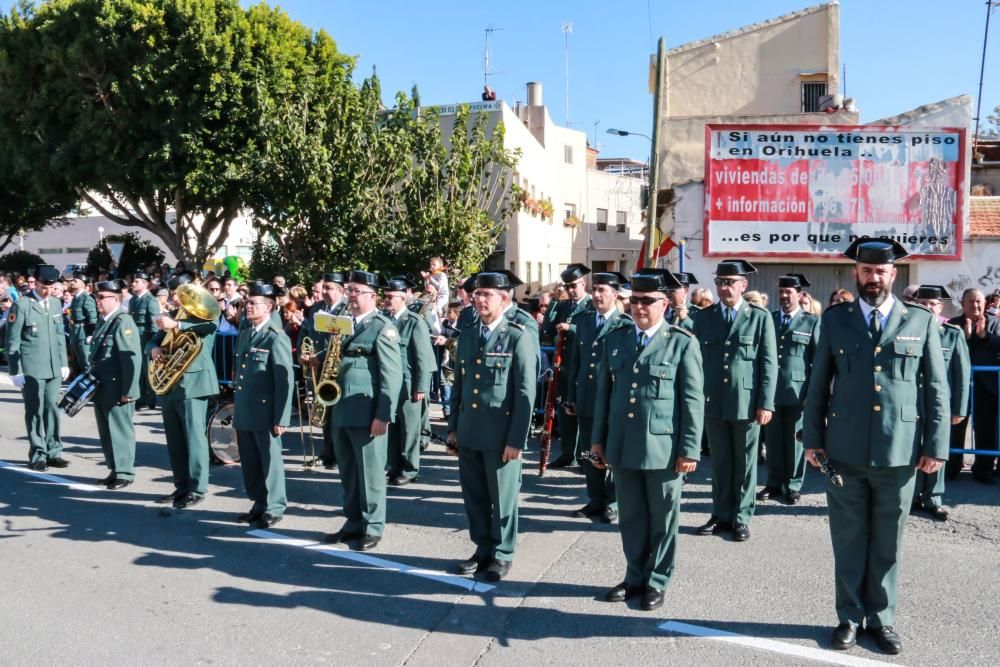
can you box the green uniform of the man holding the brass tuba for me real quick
[145,317,219,498]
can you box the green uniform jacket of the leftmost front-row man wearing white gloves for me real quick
[7,297,69,380]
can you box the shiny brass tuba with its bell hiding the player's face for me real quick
[147,283,222,396]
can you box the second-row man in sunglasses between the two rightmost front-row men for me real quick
[694,259,778,542]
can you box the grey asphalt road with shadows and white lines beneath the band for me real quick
[0,387,1000,667]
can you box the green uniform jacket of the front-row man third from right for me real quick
[448,318,538,451]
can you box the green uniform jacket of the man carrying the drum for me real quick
[90,309,142,406]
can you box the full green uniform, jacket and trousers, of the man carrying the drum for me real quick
[88,308,143,480]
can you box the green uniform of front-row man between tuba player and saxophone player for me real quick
[233,319,294,518]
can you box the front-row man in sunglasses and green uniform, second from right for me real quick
[590,269,705,611]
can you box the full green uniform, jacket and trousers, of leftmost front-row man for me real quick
[7,296,68,466]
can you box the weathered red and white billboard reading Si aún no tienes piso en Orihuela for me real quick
[704,125,968,260]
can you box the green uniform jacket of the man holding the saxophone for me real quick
[330,311,403,428]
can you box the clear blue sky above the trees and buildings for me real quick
[268,0,1000,159]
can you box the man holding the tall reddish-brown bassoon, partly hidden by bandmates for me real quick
[544,264,594,468]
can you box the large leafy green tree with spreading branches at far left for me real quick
[0,0,351,266]
